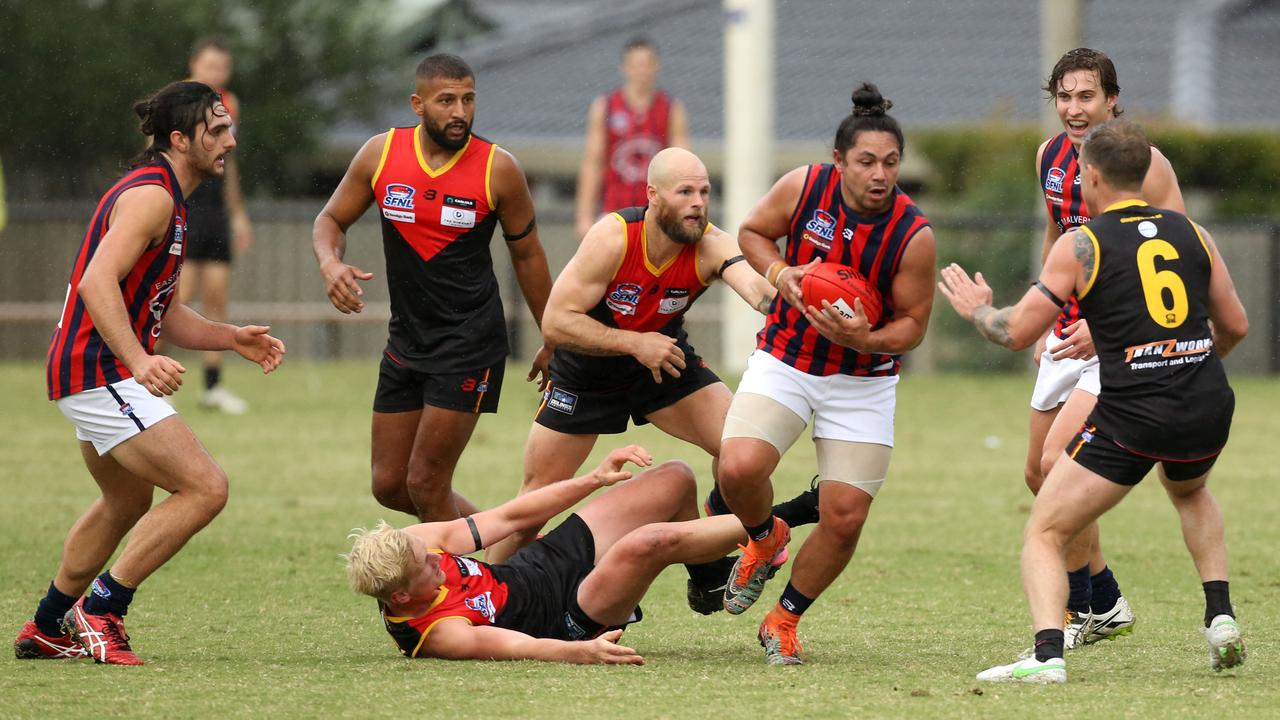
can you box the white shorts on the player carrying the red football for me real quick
[737,350,897,451]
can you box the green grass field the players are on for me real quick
[0,361,1280,719]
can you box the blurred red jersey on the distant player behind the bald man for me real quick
[602,88,671,209]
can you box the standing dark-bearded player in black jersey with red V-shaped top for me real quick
[312,54,552,520]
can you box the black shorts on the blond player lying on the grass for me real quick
[493,514,641,641]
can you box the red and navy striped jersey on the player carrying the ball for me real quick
[756,164,929,377]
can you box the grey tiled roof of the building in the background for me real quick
[344,0,1280,152]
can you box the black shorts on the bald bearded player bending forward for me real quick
[534,346,721,436]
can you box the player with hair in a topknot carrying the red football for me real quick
[719,83,934,665]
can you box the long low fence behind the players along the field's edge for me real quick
[0,200,1280,373]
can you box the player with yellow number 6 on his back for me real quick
[938,120,1248,683]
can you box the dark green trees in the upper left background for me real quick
[0,0,397,197]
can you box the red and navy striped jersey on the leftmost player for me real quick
[45,159,187,400]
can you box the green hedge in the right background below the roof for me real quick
[910,123,1280,217]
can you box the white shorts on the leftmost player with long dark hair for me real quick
[58,378,178,455]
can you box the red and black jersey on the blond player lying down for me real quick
[378,550,508,657]
